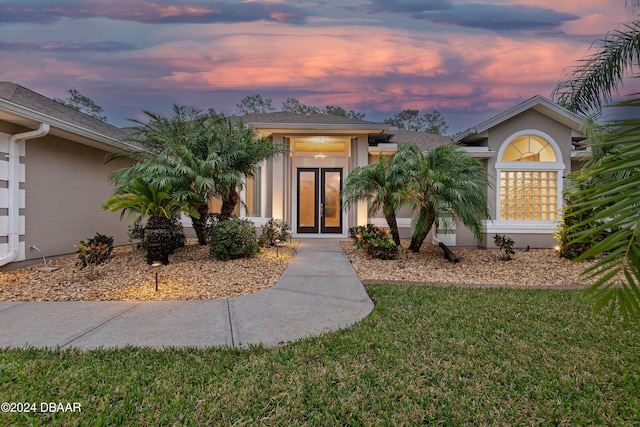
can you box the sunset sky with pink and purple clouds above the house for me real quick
[0,0,635,134]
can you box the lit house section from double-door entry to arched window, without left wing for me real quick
[242,96,585,248]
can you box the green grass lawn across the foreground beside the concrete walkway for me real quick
[0,285,640,426]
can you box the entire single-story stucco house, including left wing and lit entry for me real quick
[0,82,584,268]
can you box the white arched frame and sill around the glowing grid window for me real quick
[496,129,566,234]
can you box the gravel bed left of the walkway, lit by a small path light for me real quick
[0,239,298,301]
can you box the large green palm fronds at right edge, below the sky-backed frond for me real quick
[569,98,640,322]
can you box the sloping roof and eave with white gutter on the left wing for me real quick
[0,81,132,152]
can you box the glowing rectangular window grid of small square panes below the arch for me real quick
[500,171,558,221]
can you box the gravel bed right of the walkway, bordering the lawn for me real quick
[341,241,592,287]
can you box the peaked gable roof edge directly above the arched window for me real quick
[453,95,584,143]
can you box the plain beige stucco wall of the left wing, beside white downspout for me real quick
[23,136,130,260]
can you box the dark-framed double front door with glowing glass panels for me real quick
[297,168,342,234]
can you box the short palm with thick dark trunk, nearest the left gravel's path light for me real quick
[102,177,199,264]
